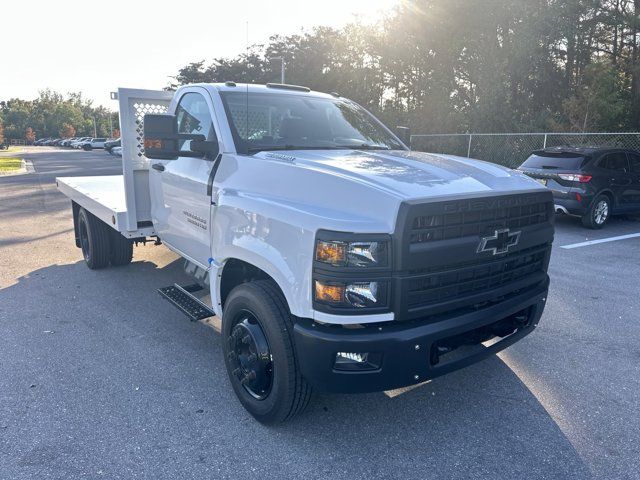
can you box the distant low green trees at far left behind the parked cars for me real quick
[0,90,118,143]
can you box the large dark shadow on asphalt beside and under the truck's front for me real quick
[0,261,591,479]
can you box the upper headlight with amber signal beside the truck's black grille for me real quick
[315,240,389,267]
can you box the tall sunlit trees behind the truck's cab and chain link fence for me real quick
[168,0,640,133]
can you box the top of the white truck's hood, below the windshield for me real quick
[258,150,544,199]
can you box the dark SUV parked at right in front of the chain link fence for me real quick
[519,147,640,228]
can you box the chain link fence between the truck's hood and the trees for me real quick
[411,133,640,168]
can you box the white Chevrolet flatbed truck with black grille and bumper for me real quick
[57,82,554,423]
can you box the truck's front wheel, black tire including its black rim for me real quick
[222,280,311,424]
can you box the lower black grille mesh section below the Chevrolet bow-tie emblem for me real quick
[405,245,549,309]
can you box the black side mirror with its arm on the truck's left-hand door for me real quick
[144,114,210,160]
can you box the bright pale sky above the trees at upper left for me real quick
[0,0,400,109]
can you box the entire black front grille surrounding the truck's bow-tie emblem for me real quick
[394,191,554,321]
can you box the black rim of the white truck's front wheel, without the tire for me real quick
[227,310,273,400]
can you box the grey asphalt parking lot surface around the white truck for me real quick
[0,147,640,479]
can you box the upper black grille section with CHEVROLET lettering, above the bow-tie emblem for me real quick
[410,197,549,244]
